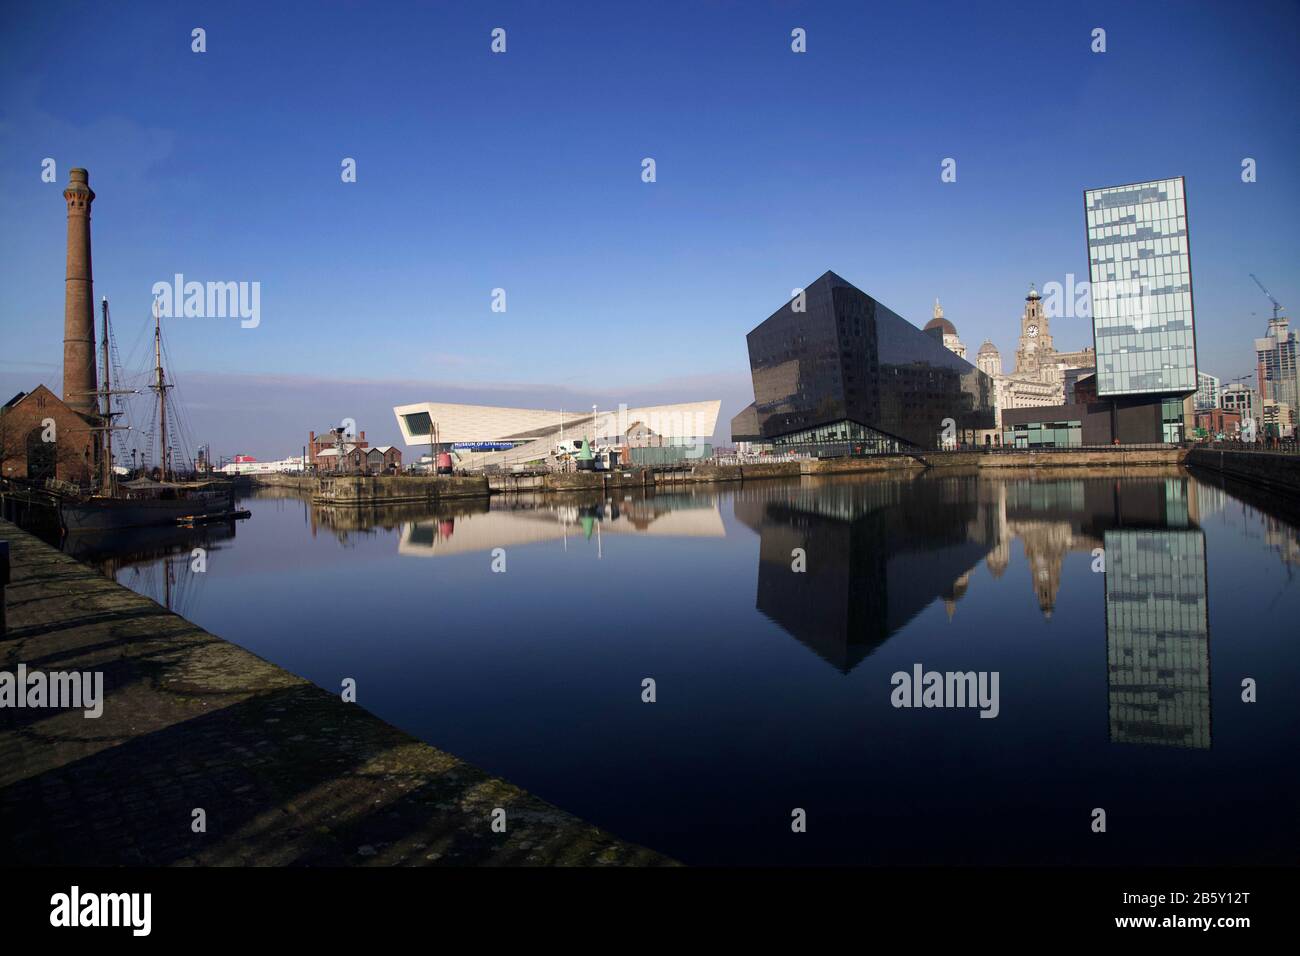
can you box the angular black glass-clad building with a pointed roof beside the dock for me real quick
[732,272,995,454]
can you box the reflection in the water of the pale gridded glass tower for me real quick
[1105,528,1210,749]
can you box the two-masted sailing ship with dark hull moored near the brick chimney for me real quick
[55,298,239,533]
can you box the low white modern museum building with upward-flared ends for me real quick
[393,399,722,464]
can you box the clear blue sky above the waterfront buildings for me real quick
[0,3,1300,457]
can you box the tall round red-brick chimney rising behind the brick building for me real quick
[64,169,99,415]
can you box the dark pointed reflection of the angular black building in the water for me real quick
[736,477,996,672]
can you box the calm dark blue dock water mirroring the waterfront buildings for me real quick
[53,468,1300,864]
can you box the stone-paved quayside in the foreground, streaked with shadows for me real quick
[0,520,673,866]
